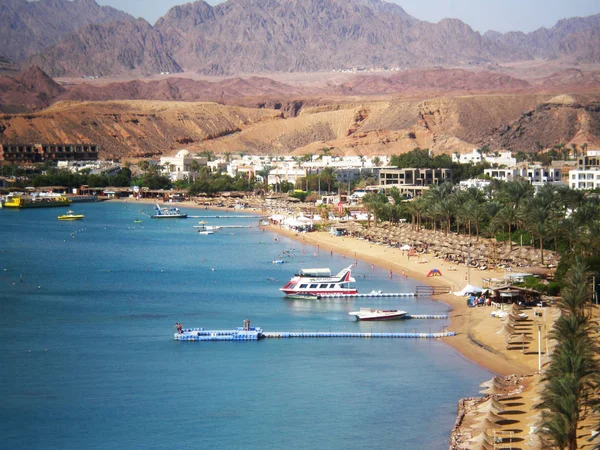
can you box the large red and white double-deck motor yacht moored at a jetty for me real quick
[279,266,358,298]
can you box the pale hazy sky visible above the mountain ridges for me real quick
[96,0,600,33]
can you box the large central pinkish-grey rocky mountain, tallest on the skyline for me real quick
[155,0,512,74]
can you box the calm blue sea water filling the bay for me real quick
[0,200,492,450]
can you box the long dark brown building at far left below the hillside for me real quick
[0,144,98,164]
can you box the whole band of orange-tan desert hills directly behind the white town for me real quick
[0,93,600,158]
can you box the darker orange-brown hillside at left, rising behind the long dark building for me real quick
[0,101,281,158]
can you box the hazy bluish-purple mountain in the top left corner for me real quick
[0,0,132,62]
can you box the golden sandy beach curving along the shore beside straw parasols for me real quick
[120,199,554,449]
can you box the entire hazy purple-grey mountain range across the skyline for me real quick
[0,0,600,76]
